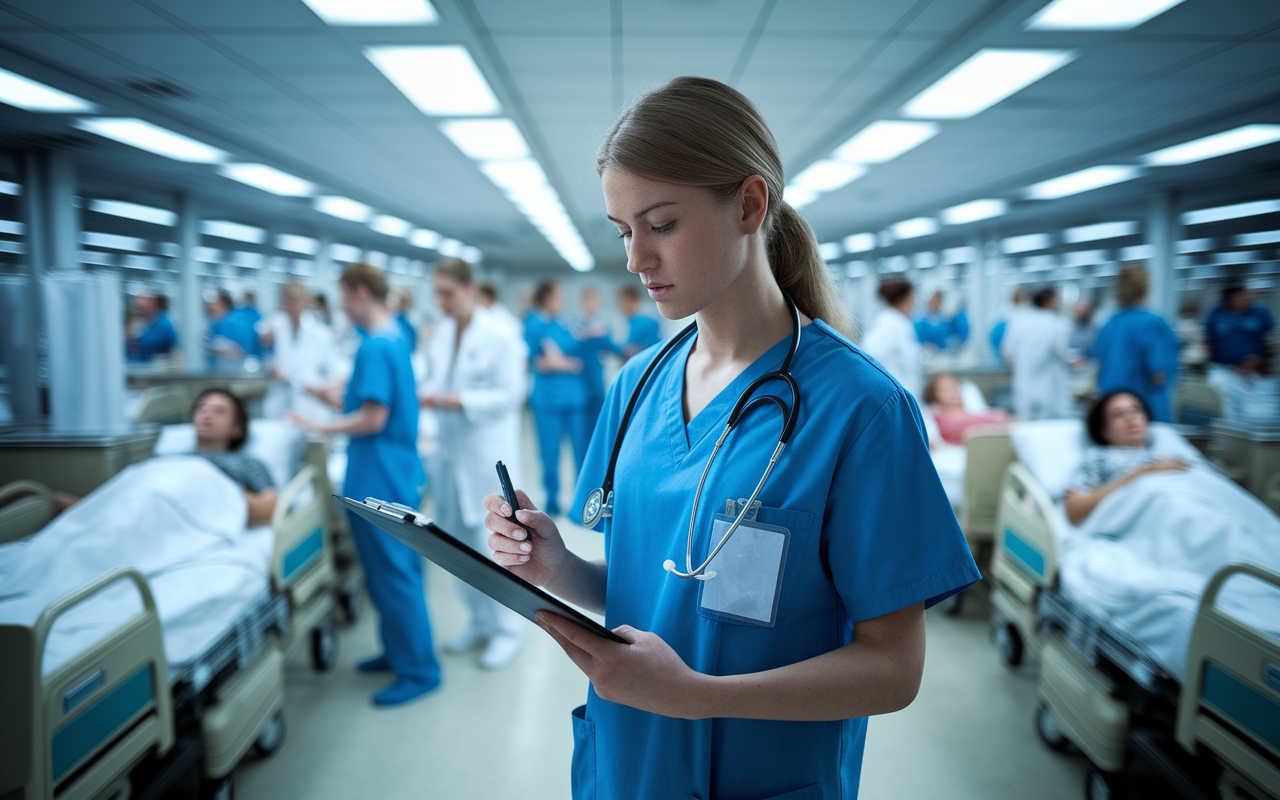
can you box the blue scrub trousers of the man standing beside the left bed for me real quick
[348,512,440,684]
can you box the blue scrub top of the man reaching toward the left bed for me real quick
[342,323,425,507]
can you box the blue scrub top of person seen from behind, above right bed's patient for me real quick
[1089,308,1179,422]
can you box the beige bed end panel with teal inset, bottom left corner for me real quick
[0,567,174,797]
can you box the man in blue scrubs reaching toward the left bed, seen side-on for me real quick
[288,264,440,705]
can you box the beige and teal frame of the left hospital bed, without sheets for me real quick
[0,422,337,800]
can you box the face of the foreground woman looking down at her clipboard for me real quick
[603,168,763,320]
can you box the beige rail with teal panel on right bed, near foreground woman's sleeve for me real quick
[991,462,1057,602]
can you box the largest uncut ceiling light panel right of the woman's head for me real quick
[902,47,1075,119]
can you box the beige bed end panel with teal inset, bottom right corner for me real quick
[1176,563,1280,796]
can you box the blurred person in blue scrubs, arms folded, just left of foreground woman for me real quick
[525,280,589,516]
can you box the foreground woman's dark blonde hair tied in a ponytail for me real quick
[595,77,854,338]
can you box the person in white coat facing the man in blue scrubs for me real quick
[419,259,526,669]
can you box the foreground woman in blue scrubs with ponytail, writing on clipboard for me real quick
[485,78,979,800]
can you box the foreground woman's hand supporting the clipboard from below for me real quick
[538,611,707,719]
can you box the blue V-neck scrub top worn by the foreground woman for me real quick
[572,321,980,800]
